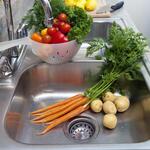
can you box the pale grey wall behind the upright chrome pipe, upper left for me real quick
[0,0,34,41]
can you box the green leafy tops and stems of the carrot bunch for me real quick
[85,23,147,100]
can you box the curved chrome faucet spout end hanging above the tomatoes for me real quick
[40,0,53,27]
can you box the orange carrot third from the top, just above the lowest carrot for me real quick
[32,97,88,124]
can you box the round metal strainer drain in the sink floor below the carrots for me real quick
[64,117,99,143]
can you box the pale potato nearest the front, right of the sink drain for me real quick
[103,114,117,129]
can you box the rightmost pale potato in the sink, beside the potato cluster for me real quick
[114,96,130,112]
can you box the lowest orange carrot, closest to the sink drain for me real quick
[37,105,89,135]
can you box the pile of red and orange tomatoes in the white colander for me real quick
[31,13,71,44]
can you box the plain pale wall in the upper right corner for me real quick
[124,0,150,38]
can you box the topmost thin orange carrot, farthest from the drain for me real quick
[31,94,83,115]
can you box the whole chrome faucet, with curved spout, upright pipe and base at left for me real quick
[0,0,53,78]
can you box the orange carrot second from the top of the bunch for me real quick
[33,97,83,121]
